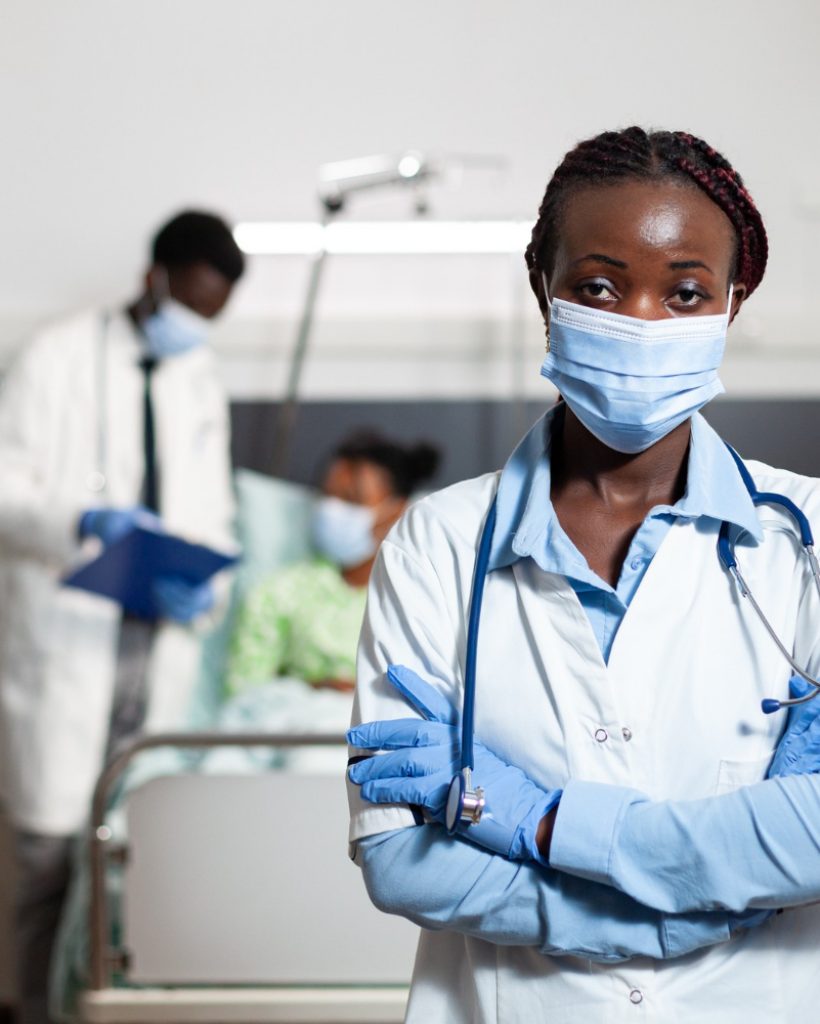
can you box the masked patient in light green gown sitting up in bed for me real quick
[212,432,438,770]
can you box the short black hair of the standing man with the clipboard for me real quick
[152,210,245,282]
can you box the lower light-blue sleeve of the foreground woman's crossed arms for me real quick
[356,824,741,963]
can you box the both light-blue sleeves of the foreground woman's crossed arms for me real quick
[351,536,820,962]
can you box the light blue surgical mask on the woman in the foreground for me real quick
[541,281,732,455]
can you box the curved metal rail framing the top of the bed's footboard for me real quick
[88,732,347,991]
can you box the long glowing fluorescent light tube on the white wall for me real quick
[233,220,532,256]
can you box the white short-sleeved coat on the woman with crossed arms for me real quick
[348,463,820,1024]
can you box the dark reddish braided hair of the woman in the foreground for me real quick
[525,127,769,297]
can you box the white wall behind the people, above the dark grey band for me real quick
[0,0,820,395]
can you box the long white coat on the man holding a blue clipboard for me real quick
[0,312,233,835]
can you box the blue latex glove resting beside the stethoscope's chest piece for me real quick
[347,665,561,863]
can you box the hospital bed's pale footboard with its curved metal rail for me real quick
[81,733,418,1024]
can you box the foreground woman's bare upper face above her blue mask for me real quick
[533,179,745,321]
